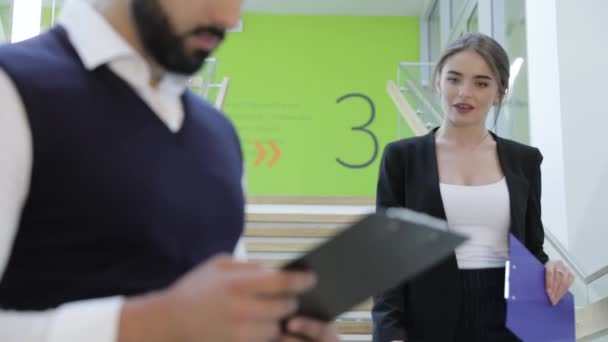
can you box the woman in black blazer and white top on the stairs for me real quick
[372,33,573,342]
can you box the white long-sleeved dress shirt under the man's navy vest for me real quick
[0,0,246,342]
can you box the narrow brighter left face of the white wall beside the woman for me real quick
[526,0,569,248]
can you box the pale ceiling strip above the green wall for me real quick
[243,0,432,16]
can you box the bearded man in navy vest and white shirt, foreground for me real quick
[0,0,337,342]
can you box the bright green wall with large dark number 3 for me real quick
[216,14,420,196]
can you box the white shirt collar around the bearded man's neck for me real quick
[59,0,190,94]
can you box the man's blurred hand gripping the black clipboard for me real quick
[119,256,318,342]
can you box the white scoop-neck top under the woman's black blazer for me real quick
[439,177,511,269]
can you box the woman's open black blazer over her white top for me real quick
[372,131,548,342]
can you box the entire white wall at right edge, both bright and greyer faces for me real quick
[527,0,608,272]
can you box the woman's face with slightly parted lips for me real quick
[437,50,500,127]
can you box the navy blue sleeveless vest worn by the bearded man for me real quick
[0,27,244,310]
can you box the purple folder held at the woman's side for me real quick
[505,235,575,342]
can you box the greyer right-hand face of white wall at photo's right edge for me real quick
[557,0,608,272]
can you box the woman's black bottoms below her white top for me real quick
[455,268,521,342]
